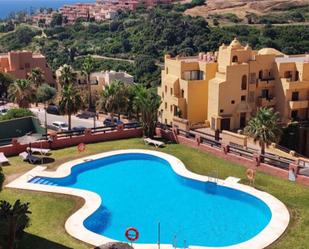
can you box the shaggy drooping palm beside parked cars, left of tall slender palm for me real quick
[59,84,84,130]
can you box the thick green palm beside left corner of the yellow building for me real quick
[134,87,161,138]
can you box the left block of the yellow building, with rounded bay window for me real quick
[158,53,217,128]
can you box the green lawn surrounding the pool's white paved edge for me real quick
[0,139,309,249]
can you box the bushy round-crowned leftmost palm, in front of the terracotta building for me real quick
[8,79,35,108]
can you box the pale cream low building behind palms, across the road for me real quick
[56,67,134,96]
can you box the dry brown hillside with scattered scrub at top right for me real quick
[185,0,309,24]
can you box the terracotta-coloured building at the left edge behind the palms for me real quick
[0,51,55,85]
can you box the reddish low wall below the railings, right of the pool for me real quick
[157,129,309,186]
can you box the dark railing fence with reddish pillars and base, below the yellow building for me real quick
[157,125,309,185]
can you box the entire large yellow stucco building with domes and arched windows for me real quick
[158,39,309,130]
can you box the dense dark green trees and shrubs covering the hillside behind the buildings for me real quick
[0,6,309,85]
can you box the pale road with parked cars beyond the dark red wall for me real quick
[30,108,103,128]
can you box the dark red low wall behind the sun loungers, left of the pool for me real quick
[0,128,143,156]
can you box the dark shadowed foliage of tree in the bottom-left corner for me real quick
[0,200,31,249]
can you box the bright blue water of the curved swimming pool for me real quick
[30,153,271,247]
